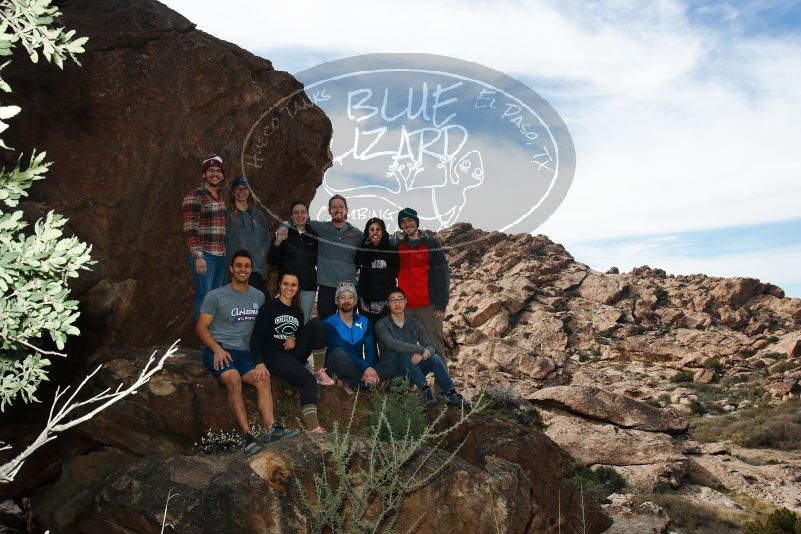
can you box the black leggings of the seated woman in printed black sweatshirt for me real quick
[264,319,325,406]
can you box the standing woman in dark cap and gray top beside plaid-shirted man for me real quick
[225,176,270,295]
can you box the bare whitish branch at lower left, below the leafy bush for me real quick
[0,340,180,484]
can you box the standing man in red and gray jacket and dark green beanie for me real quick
[397,208,450,358]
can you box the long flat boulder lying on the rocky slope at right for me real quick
[529,385,688,434]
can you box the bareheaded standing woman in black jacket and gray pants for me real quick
[268,200,317,323]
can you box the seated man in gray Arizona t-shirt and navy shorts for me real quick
[195,250,300,456]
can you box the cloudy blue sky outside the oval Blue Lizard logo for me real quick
[166,0,801,297]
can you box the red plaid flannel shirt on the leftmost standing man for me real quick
[183,187,225,259]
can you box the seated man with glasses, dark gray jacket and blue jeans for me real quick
[375,287,472,410]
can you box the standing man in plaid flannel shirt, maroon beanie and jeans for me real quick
[182,154,226,321]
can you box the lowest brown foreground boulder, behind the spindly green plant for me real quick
[35,435,530,534]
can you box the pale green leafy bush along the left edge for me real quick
[0,0,92,411]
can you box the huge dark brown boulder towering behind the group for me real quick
[0,0,332,354]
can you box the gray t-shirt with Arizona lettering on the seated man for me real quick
[200,284,264,351]
